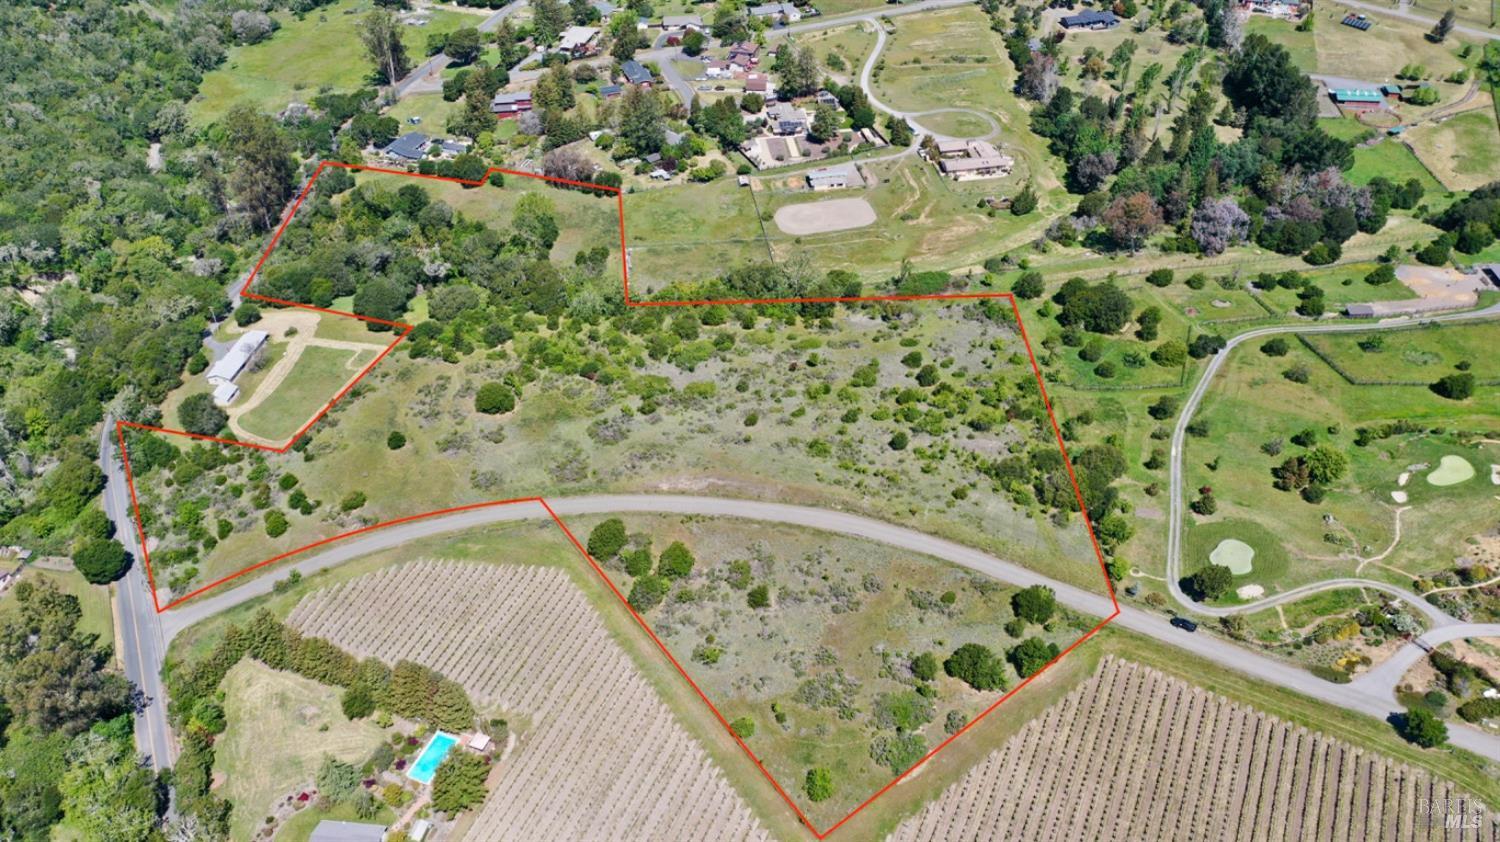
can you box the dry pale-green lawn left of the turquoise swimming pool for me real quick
[213,659,386,839]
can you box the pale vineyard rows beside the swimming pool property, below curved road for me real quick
[290,561,768,842]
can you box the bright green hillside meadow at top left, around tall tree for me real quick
[191,0,483,125]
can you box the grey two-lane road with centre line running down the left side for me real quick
[99,416,177,771]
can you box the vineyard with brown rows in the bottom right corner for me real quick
[888,659,1500,842]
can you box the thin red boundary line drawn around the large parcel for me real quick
[116,161,1121,839]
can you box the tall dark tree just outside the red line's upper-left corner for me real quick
[221,105,297,231]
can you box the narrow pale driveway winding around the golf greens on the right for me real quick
[1167,305,1500,609]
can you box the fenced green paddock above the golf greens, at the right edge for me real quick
[1308,324,1500,383]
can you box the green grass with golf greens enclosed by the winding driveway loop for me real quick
[1185,332,1500,593]
